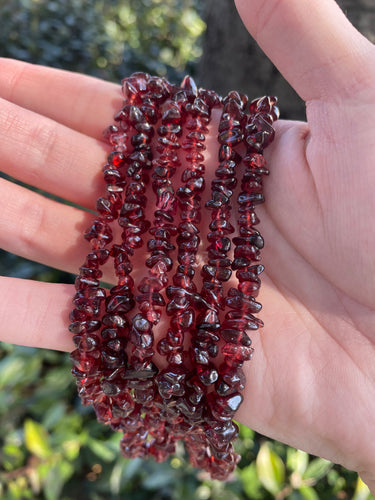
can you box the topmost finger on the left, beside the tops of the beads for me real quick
[0,58,123,140]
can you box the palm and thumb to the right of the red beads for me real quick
[236,0,375,491]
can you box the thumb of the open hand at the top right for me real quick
[235,0,375,101]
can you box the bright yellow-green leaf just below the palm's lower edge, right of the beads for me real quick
[256,442,285,495]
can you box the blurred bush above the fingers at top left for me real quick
[0,0,205,81]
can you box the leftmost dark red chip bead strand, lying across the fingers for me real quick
[69,115,135,408]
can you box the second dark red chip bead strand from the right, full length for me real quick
[192,92,247,479]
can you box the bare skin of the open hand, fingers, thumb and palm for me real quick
[0,0,375,493]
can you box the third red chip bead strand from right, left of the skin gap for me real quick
[157,77,221,422]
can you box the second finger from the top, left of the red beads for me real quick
[0,99,109,209]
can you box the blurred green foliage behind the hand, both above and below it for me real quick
[0,0,373,500]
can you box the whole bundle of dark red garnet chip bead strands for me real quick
[69,73,278,479]
